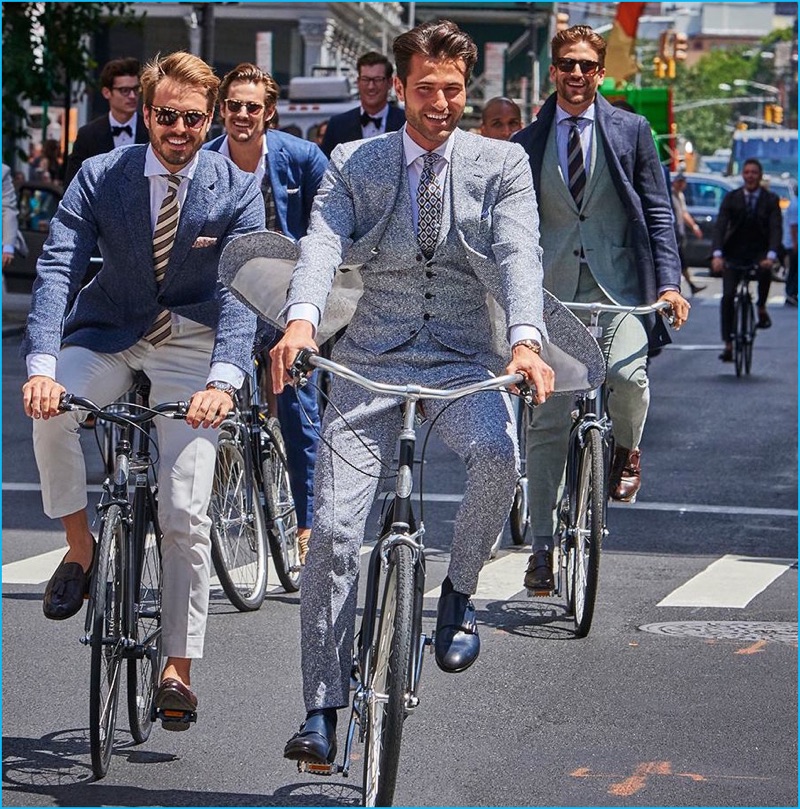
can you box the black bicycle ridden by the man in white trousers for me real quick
[59,376,189,779]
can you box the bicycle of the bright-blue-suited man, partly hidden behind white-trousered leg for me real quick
[209,356,302,612]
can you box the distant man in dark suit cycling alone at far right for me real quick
[711,158,783,362]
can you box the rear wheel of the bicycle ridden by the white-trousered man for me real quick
[128,495,162,744]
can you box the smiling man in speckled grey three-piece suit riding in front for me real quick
[272,17,554,763]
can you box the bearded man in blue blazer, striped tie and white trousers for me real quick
[22,53,264,730]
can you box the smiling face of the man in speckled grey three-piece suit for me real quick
[394,54,467,151]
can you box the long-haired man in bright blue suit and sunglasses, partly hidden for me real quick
[209,62,328,564]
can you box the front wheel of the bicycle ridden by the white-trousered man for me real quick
[89,505,128,778]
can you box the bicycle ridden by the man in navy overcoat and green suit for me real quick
[512,301,669,638]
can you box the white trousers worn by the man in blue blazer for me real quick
[33,320,217,658]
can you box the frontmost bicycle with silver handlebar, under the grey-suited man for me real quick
[293,349,530,806]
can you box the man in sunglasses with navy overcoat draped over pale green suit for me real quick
[512,25,690,591]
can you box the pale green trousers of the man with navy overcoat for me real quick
[526,265,650,550]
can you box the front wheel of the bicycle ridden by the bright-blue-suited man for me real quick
[209,430,267,612]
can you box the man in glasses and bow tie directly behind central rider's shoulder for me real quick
[322,51,406,157]
